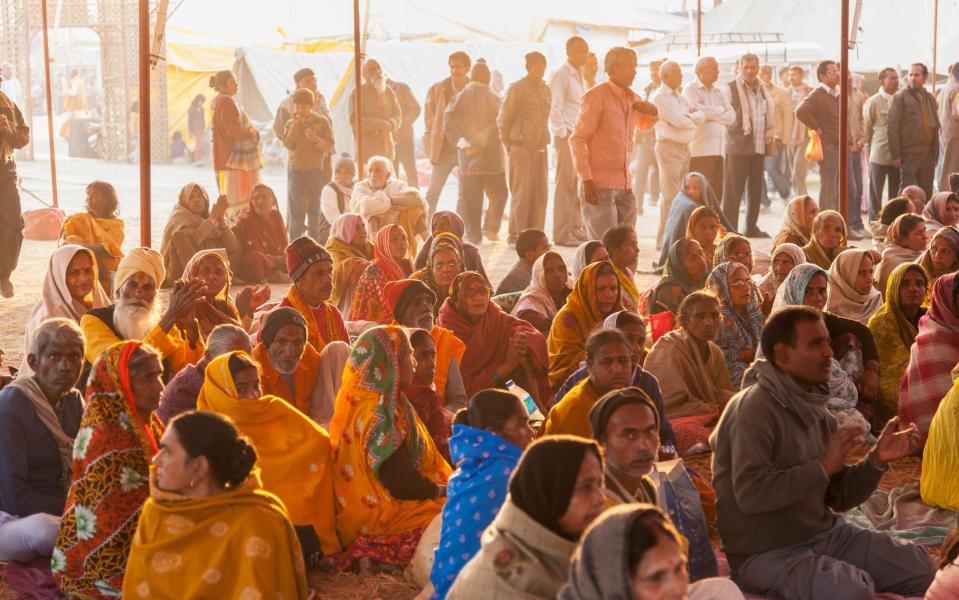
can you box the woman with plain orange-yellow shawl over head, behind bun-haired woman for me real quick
[196,351,340,566]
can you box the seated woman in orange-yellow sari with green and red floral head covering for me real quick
[330,325,451,568]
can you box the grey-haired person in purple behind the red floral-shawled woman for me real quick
[156,323,252,424]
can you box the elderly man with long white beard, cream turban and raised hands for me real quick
[80,248,205,380]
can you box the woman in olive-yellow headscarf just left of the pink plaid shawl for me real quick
[869,263,929,423]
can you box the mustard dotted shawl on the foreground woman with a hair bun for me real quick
[123,467,309,600]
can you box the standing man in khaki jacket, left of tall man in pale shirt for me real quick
[498,52,551,244]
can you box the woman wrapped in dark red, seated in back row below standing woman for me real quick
[234,183,290,283]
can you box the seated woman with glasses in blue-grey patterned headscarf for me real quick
[707,262,765,389]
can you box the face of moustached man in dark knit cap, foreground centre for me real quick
[603,403,659,479]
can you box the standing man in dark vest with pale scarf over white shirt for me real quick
[723,54,775,238]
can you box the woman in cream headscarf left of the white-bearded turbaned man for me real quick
[20,244,110,376]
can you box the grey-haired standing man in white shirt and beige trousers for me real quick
[653,60,706,249]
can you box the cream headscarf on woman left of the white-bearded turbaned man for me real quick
[20,244,110,375]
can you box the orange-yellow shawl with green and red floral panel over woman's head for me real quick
[328,325,452,547]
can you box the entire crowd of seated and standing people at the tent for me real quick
[9,37,959,599]
